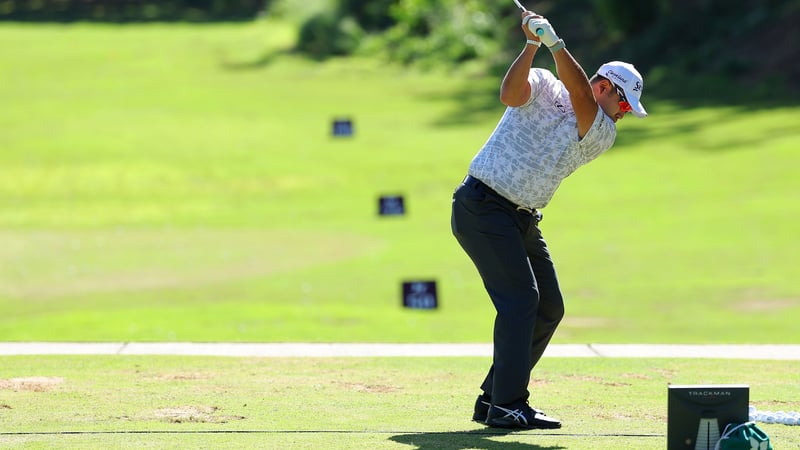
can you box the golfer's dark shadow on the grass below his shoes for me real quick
[389,430,566,450]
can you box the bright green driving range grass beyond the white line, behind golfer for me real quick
[0,21,800,343]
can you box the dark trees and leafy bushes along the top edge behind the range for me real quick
[0,0,800,92]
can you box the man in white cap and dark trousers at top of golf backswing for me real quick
[452,11,647,428]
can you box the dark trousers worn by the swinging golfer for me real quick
[451,177,564,405]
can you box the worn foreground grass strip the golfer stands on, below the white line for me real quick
[0,356,800,450]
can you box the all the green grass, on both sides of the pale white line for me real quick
[0,21,800,450]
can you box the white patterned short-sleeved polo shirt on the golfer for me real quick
[469,69,617,208]
